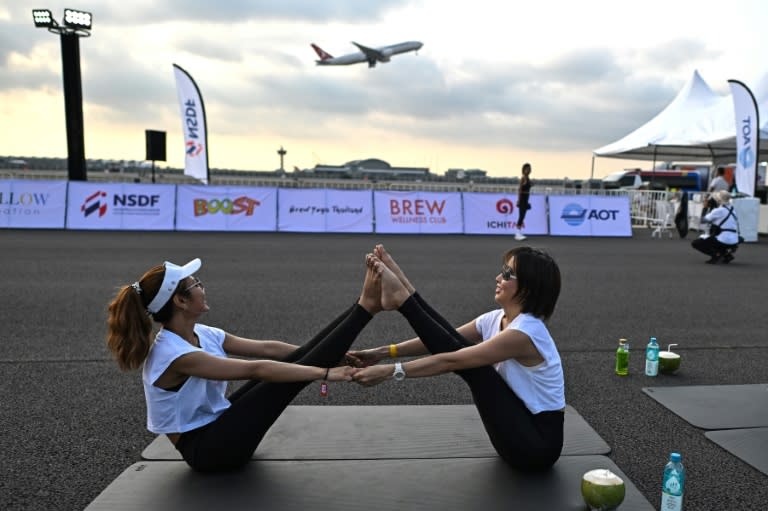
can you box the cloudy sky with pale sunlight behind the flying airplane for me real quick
[0,0,768,179]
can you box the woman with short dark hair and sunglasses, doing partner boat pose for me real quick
[349,245,565,471]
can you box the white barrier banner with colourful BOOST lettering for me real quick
[176,185,277,231]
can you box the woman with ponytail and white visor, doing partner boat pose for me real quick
[107,259,381,472]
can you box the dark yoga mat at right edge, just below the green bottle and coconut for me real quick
[643,384,768,429]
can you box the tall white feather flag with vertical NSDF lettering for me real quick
[173,64,208,184]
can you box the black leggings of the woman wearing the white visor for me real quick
[176,304,372,472]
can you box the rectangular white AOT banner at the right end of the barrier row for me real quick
[549,195,632,236]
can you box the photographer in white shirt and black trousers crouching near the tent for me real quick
[691,190,739,264]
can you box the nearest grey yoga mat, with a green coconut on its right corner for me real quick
[86,456,654,511]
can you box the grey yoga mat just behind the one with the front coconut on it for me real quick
[141,405,611,461]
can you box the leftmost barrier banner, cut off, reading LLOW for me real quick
[0,179,67,229]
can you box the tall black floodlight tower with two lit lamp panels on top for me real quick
[32,9,93,181]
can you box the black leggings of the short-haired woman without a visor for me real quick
[398,293,565,471]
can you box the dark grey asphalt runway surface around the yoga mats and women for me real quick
[0,229,768,510]
